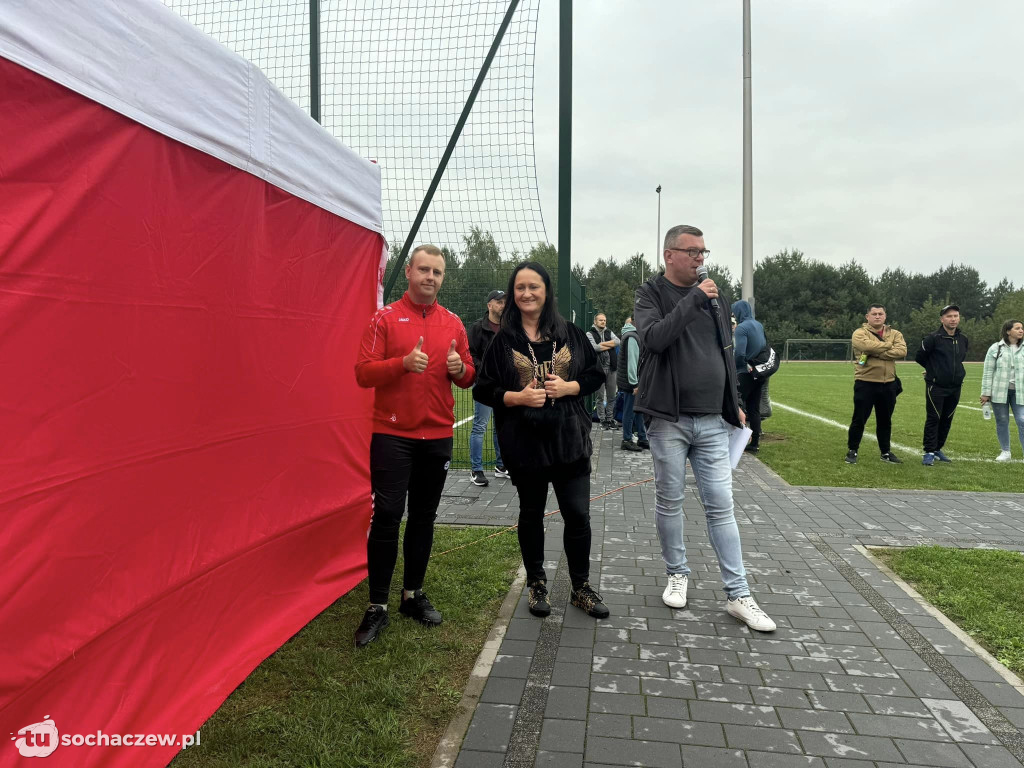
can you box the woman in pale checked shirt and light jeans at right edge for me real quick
[981,321,1024,462]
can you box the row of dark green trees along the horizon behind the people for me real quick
[392,227,1024,359]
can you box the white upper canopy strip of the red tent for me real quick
[0,0,383,232]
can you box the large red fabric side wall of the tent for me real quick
[0,58,383,766]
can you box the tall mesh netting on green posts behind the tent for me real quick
[156,0,594,468]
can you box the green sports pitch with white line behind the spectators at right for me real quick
[759,362,1024,493]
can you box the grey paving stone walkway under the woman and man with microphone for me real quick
[440,423,1024,768]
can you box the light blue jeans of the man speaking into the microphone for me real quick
[647,414,751,599]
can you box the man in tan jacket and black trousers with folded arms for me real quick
[846,304,906,464]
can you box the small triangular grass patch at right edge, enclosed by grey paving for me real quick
[871,547,1024,675]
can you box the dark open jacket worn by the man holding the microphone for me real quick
[633,274,740,427]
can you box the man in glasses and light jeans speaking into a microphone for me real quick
[633,225,775,632]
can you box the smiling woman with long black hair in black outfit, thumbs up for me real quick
[473,261,608,618]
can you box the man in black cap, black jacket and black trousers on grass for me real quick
[913,304,968,467]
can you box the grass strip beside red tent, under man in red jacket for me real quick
[171,526,519,768]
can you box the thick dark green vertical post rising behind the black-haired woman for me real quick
[556,0,572,319]
